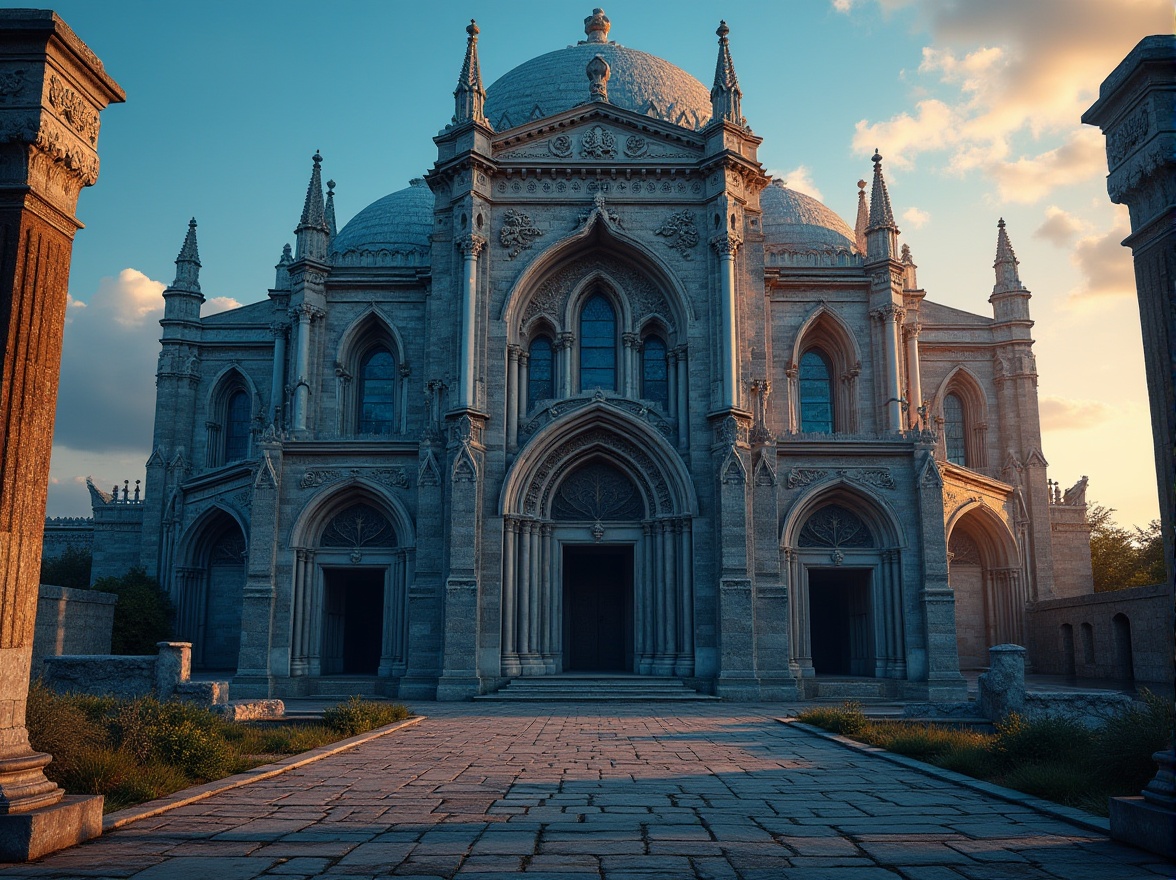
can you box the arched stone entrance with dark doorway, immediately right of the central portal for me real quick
[783,486,907,679]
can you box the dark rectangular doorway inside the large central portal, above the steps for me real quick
[563,546,633,672]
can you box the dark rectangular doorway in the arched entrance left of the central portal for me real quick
[322,568,385,675]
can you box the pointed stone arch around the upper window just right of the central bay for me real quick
[788,302,862,434]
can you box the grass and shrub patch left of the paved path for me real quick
[26,681,410,813]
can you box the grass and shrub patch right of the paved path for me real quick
[796,691,1176,816]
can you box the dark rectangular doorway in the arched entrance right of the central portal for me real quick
[808,568,874,675]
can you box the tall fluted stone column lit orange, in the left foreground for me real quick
[0,9,126,861]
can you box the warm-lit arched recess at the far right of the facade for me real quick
[948,504,1025,669]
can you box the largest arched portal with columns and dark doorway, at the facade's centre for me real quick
[502,401,695,675]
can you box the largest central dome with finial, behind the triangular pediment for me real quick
[486,9,710,132]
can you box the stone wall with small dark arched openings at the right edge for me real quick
[1028,584,1172,693]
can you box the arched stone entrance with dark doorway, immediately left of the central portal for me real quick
[290,486,412,678]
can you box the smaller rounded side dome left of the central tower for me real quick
[330,178,435,266]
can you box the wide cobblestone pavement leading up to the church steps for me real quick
[0,704,1172,880]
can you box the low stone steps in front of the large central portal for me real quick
[474,674,719,702]
